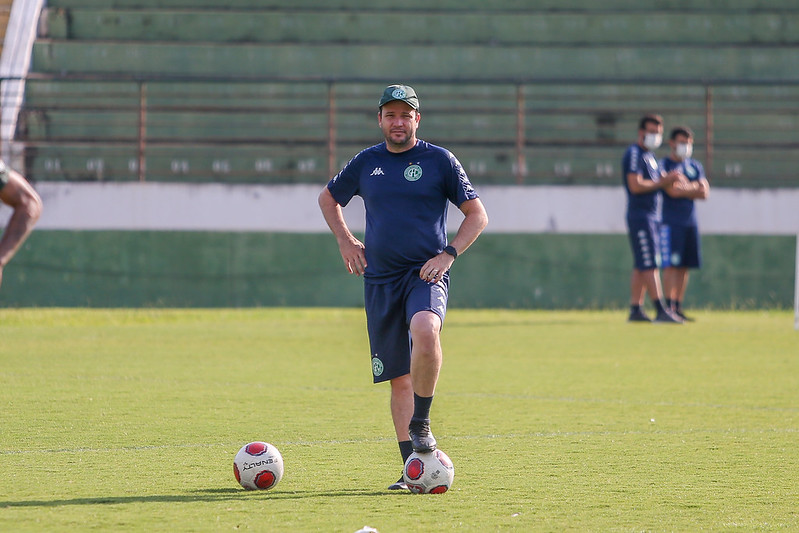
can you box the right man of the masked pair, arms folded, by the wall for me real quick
[660,126,710,320]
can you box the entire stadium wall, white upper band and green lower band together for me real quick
[0,183,799,308]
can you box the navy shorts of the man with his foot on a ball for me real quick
[364,268,449,383]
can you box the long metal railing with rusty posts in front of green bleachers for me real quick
[3,75,799,187]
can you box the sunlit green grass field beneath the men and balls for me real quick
[0,309,799,533]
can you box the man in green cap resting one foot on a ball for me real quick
[319,85,488,489]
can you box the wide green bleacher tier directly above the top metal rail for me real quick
[32,40,799,82]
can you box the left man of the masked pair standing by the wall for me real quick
[622,115,684,323]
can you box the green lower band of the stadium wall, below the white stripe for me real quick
[0,230,795,309]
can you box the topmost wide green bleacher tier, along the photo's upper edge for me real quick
[44,8,799,46]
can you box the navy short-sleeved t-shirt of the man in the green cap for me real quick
[327,140,478,283]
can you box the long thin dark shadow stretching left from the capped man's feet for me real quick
[0,488,400,509]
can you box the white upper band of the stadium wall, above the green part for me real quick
[0,182,799,235]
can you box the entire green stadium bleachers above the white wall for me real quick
[12,0,799,186]
